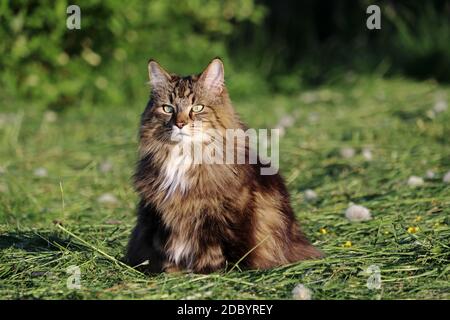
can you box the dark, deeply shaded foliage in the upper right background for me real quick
[232,0,450,87]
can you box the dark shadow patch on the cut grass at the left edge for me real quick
[0,231,88,252]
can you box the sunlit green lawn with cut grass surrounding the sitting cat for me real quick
[0,77,450,299]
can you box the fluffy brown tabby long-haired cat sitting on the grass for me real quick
[126,58,322,273]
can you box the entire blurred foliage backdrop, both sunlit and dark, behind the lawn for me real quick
[0,0,450,109]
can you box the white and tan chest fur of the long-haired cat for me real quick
[159,152,236,269]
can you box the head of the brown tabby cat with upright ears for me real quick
[141,58,234,148]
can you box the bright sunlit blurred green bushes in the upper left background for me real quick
[0,0,265,109]
